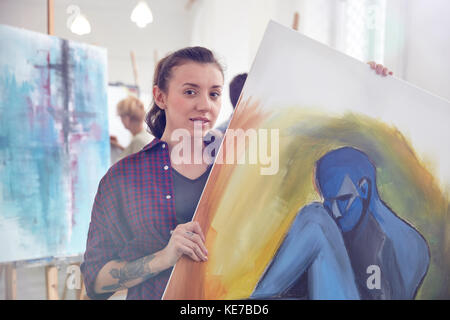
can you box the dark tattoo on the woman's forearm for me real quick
[102,254,158,291]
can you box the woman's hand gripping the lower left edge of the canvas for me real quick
[162,221,208,267]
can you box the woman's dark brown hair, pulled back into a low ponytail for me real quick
[145,47,223,139]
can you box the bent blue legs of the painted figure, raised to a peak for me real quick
[250,202,359,300]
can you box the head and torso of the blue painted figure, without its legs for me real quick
[316,147,430,299]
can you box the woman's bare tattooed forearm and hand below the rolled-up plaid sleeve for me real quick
[95,222,208,294]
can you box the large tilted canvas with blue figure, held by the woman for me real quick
[164,22,450,299]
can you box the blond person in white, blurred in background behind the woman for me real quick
[111,96,153,159]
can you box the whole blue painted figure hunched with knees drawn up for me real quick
[252,147,430,300]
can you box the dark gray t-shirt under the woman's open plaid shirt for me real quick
[172,165,212,224]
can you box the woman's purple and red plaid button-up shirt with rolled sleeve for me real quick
[81,138,176,299]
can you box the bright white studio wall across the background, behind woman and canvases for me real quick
[0,0,450,106]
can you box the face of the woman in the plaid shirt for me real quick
[154,62,223,137]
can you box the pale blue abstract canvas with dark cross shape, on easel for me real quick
[0,26,110,262]
